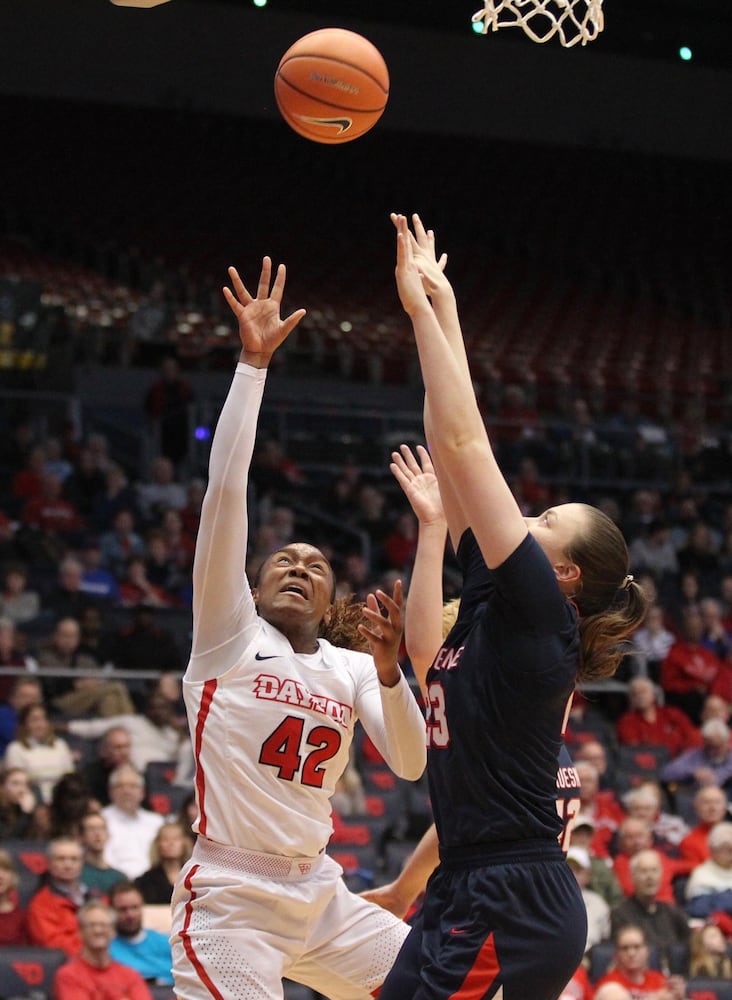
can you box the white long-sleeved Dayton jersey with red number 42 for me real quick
[183,364,425,857]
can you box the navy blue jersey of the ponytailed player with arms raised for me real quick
[427,530,579,850]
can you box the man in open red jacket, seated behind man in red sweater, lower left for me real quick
[28,837,89,957]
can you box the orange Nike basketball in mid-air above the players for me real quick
[275,28,389,143]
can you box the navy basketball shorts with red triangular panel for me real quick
[379,841,587,1000]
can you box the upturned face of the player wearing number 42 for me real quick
[252,542,333,634]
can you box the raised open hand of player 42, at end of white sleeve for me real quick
[223,257,305,368]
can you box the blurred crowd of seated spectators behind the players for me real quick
[0,350,732,1000]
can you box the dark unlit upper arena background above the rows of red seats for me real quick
[0,0,732,388]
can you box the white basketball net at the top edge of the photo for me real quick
[473,0,604,48]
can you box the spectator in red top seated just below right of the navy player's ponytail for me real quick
[617,677,701,757]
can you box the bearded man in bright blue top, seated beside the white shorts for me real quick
[109,882,173,986]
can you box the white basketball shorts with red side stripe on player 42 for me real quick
[170,837,409,1000]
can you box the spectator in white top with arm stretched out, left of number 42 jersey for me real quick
[62,690,188,774]
